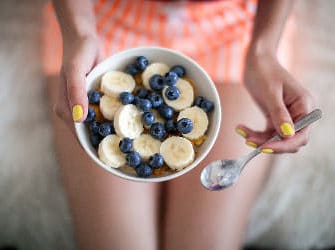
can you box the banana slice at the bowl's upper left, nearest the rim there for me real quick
[101,71,136,97]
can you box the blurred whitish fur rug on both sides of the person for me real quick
[0,0,335,250]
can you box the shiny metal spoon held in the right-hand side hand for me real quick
[200,109,322,191]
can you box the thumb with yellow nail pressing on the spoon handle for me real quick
[267,95,295,137]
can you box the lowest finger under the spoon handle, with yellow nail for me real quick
[261,128,310,153]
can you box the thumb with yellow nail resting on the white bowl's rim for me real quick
[65,68,88,122]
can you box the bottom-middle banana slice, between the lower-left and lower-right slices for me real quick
[133,134,161,161]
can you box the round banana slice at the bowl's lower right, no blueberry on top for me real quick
[160,136,195,171]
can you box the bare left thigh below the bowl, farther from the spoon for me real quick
[49,75,159,250]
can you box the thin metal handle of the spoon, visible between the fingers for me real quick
[247,109,322,161]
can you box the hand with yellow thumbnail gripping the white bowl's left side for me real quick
[55,36,101,130]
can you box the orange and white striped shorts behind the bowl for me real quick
[44,0,256,83]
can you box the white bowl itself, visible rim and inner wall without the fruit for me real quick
[75,47,221,182]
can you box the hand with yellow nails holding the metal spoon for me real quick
[237,50,314,153]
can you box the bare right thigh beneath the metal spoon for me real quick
[163,85,271,250]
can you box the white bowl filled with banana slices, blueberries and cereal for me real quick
[75,47,221,182]
